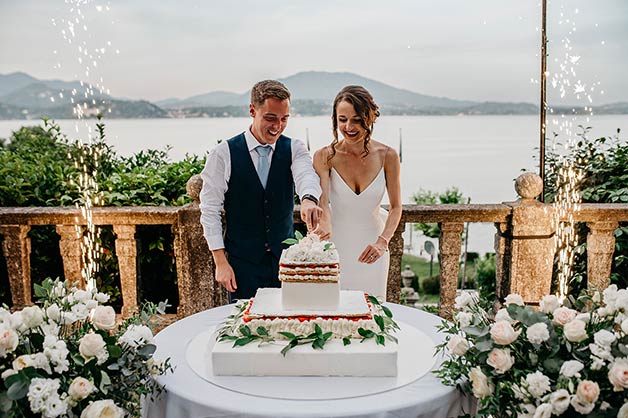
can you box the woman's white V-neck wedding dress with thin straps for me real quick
[329,167,390,299]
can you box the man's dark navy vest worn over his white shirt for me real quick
[224,134,294,263]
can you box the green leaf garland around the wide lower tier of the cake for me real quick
[216,295,399,356]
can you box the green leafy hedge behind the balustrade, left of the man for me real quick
[0,120,205,310]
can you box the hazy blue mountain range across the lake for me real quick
[0,71,628,119]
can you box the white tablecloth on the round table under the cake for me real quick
[144,304,469,418]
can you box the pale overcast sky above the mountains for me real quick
[0,0,628,104]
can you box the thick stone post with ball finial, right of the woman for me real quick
[501,173,556,304]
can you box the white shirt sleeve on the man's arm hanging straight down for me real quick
[200,142,231,250]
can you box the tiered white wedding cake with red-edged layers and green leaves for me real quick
[211,234,398,376]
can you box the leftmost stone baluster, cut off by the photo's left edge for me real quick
[0,225,32,309]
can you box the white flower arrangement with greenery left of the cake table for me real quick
[0,279,172,418]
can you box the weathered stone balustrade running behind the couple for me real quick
[0,176,628,317]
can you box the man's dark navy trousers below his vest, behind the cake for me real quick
[227,251,281,302]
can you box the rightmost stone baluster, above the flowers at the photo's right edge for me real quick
[587,222,619,291]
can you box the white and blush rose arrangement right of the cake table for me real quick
[435,285,628,418]
